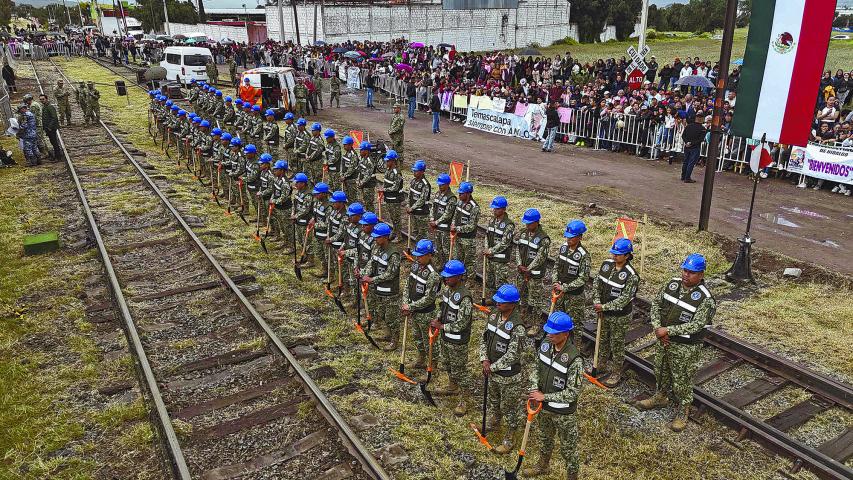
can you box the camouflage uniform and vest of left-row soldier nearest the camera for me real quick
[525,340,583,476]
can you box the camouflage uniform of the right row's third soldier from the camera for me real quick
[549,243,591,347]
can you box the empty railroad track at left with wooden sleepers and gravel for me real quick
[31,61,390,480]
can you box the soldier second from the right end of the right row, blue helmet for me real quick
[593,238,640,387]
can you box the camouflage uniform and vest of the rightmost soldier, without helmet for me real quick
[651,277,717,407]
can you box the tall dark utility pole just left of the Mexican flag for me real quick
[699,0,738,232]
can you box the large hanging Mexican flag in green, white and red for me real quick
[732,0,835,145]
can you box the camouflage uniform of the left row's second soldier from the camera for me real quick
[480,306,526,439]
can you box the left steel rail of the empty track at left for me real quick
[30,60,191,480]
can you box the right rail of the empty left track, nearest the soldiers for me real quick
[45,60,391,480]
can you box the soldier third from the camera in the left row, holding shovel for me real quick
[430,260,474,417]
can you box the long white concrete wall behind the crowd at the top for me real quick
[267,0,574,51]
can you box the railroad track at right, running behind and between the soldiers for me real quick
[56,56,853,479]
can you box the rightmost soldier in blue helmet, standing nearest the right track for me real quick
[636,253,717,432]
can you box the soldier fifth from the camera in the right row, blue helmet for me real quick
[483,196,515,304]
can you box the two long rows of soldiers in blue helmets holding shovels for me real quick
[150,90,716,479]
